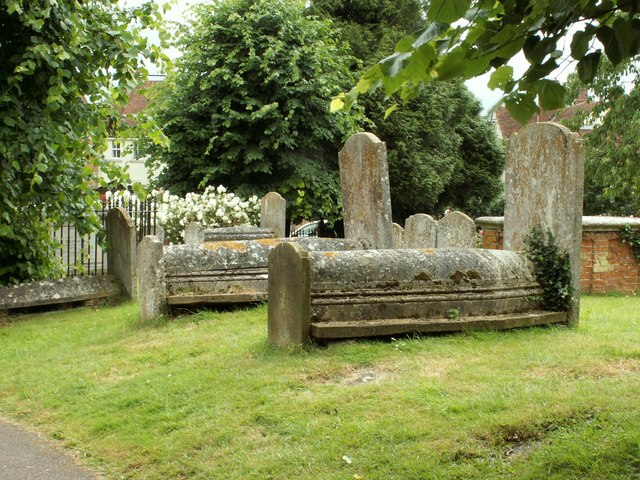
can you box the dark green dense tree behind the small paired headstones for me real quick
[312,0,504,222]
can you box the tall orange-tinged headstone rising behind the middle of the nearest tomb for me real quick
[339,133,393,249]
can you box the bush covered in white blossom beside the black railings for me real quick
[157,185,260,243]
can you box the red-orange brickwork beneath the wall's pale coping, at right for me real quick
[482,226,640,293]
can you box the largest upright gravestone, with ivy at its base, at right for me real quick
[504,123,584,324]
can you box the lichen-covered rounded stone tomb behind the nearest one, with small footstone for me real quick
[138,236,362,320]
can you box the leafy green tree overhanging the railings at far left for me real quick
[0,0,168,284]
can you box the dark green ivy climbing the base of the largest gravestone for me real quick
[524,225,574,312]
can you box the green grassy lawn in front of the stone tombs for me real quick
[0,297,640,480]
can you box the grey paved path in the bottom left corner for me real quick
[0,419,99,480]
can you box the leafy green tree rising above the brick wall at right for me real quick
[566,61,640,215]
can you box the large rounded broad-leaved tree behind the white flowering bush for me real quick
[148,0,363,222]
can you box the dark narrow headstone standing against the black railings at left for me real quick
[106,207,138,300]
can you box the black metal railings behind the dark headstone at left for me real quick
[51,196,158,277]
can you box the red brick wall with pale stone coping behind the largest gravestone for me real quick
[476,217,640,294]
